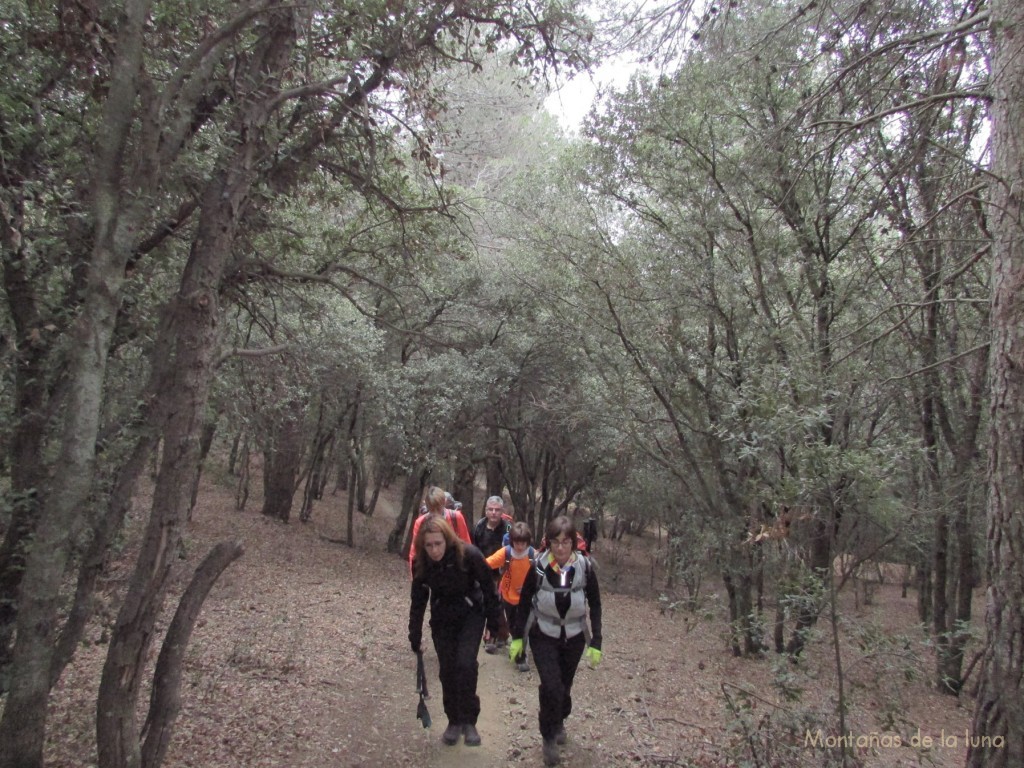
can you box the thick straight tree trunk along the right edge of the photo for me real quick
[967,0,1024,768]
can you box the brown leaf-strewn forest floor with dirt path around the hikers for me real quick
[36,478,970,768]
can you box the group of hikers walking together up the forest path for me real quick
[409,487,601,766]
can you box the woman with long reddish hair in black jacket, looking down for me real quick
[409,517,500,746]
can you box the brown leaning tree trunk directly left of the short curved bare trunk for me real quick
[96,167,247,768]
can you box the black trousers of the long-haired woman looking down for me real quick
[430,613,485,725]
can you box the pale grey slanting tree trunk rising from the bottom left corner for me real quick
[0,0,151,768]
